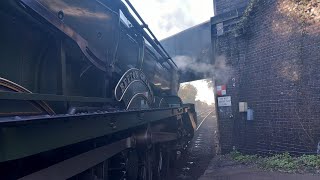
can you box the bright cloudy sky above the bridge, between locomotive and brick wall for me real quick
[130,0,213,40]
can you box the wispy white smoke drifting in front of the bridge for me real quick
[173,56,233,84]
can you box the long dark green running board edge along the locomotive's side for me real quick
[0,108,188,162]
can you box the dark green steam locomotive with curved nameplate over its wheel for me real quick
[0,0,196,179]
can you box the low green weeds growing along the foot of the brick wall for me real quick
[230,151,320,173]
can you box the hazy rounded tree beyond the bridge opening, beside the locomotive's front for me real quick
[178,84,198,104]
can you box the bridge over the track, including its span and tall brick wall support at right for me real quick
[162,0,320,154]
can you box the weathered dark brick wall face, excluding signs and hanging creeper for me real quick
[213,0,320,153]
